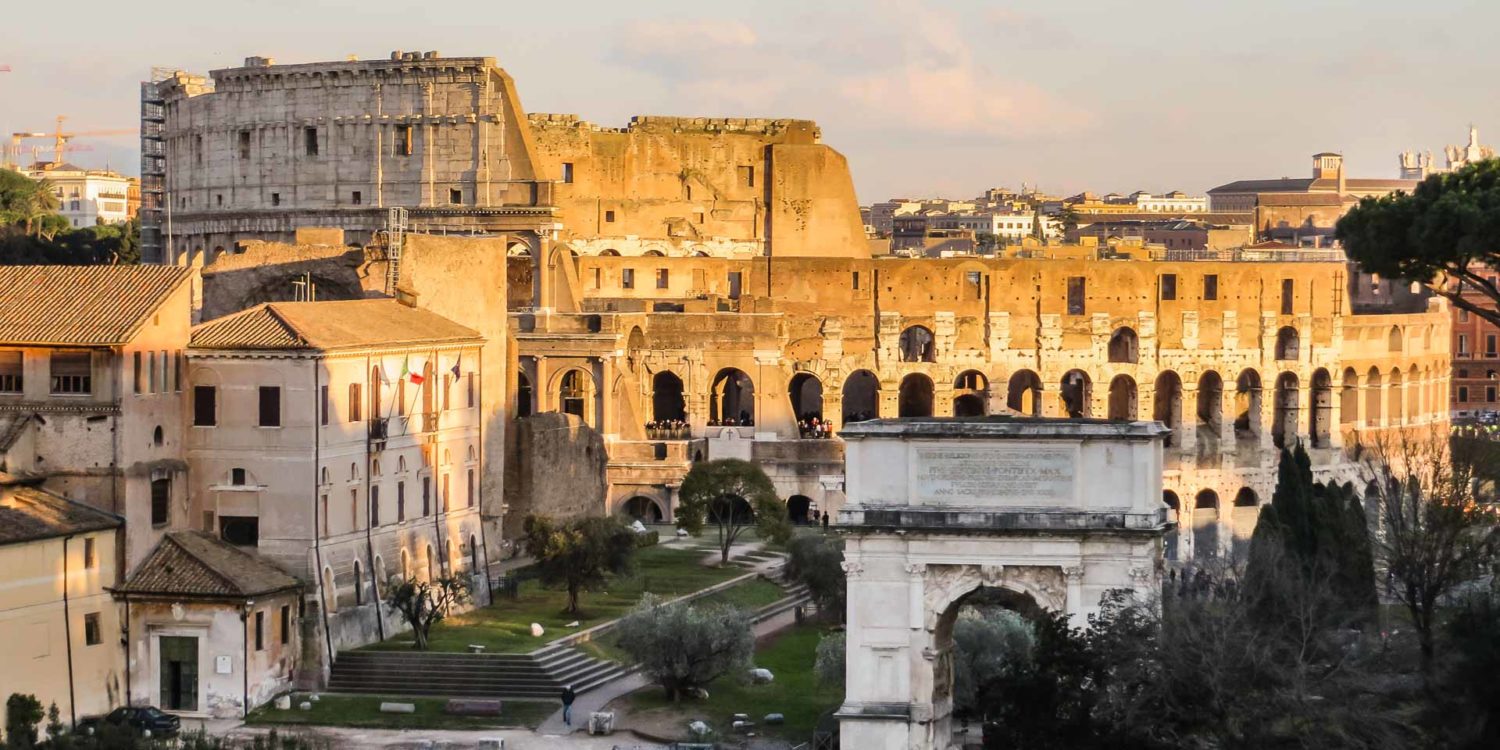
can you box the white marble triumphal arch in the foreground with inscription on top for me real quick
[839,417,1169,750]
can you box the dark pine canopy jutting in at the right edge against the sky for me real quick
[1335,159,1500,326]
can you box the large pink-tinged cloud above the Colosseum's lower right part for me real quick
[614,6,1094,138]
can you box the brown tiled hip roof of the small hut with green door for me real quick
[114,531,302,599]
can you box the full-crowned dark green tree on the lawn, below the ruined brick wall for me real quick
[524,515,636,614]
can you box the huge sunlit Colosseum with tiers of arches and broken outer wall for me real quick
[146,54,1449,560]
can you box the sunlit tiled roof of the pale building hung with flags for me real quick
[192,299,482,351]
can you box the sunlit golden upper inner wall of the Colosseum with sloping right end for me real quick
[531,114,867,257]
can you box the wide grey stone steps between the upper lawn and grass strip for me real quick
[329,647,627,698]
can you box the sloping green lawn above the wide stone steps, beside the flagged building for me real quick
[365,545,747,654]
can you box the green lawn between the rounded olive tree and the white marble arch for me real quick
[620,624,843,741]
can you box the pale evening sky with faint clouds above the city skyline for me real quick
[0,0,1500,203]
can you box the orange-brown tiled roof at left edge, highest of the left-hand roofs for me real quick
[0,266,192,347]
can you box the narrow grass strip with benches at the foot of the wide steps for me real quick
[245,693,558,729]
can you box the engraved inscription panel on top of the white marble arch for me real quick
[912,446,1077,506]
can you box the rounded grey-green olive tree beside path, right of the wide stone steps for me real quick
[615,594,755,701]
